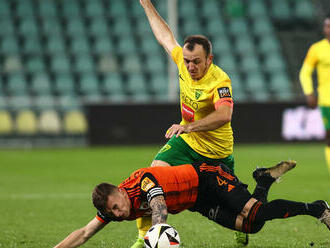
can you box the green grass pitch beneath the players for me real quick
[0,144,330,248]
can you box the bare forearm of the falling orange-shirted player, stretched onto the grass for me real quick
[54,218,106,248]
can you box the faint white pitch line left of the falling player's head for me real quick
[0,193,91,200]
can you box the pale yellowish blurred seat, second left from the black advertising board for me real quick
[38,110,62,135]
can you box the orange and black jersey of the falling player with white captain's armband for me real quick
[97,164,198,222]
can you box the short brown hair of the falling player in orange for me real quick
[92,183,118,213]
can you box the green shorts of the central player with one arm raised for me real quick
[154,136,234,171]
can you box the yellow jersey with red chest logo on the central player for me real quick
[172,46,234,159]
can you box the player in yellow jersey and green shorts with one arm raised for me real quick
[135,0,248,245]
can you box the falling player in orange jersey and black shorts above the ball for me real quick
[55,161,330,248]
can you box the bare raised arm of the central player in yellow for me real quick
[140,0,179,56]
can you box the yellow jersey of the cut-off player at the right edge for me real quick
[300,39,330,106]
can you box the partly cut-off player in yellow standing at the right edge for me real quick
[300,15,330,173]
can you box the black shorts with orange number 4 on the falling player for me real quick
[190,163,252,228]
